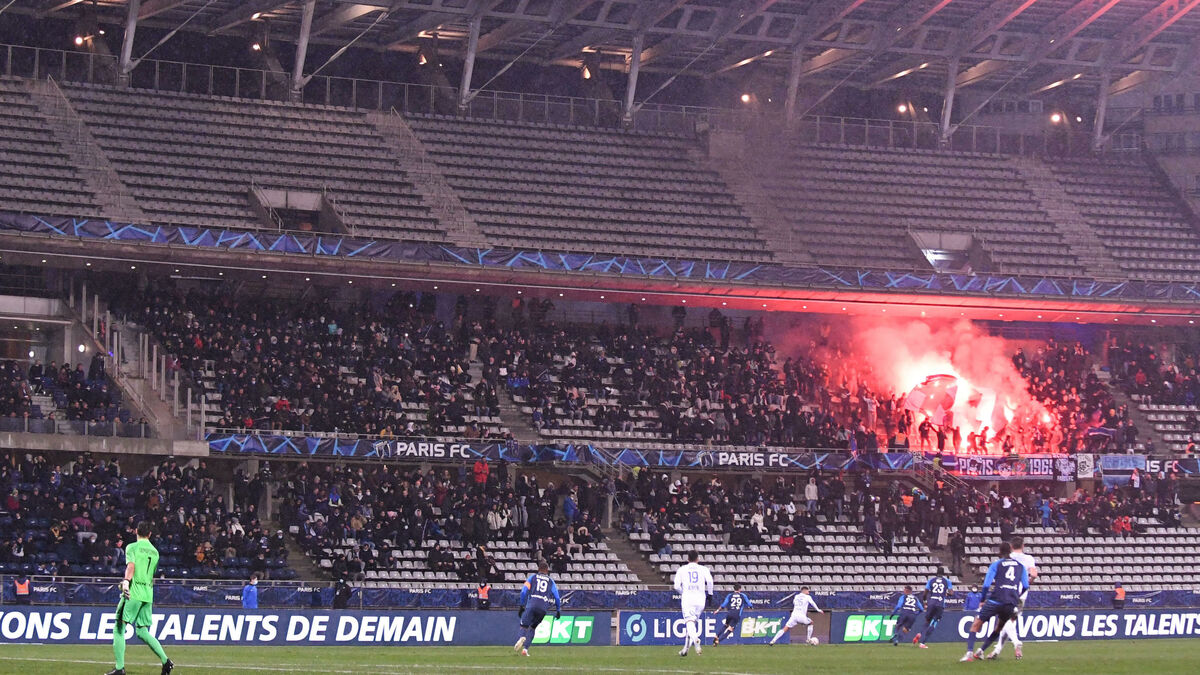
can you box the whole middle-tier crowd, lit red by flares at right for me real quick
[98,281,1166,453]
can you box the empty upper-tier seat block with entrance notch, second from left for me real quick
[64,85,444,240]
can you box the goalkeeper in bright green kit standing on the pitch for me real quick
[108,520,175,675]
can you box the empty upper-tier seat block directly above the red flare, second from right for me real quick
[762,145,1084,275]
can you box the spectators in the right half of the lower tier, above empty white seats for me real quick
[617,456,1181,573]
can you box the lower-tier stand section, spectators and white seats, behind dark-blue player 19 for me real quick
[274,461,644,590]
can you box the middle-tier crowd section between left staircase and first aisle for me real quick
[112,282,505,438]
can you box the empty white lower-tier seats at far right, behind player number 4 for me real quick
[967,519,1200,591]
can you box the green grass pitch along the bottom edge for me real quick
[0,639,1200,675]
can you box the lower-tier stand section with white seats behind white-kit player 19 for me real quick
[623,471,937,592]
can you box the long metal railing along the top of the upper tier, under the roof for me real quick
[0,44,1142,155]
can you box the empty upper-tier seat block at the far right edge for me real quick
[1050,157,1200,282]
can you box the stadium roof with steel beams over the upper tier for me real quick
[17,0,1200,94]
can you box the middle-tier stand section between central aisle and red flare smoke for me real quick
[508,317,869,448]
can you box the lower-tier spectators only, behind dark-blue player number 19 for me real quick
[277,460,606,583]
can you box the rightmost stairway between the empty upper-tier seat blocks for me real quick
[1009,157,1128,281]
